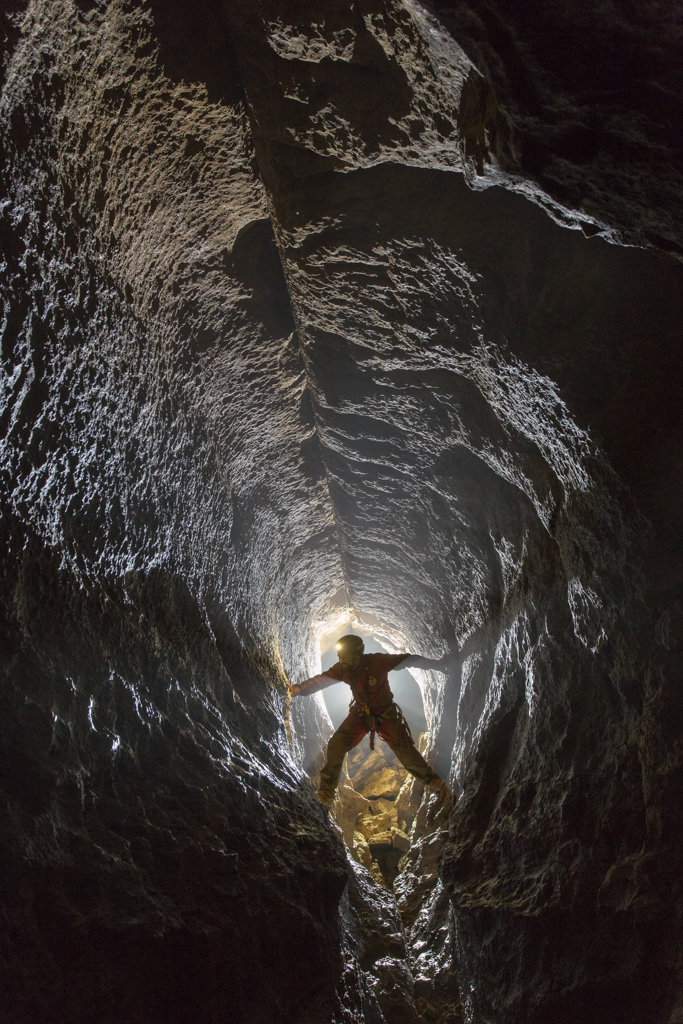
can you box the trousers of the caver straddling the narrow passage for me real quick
[317,703,438,804]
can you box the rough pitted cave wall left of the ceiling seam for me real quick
[2,3,358,1024]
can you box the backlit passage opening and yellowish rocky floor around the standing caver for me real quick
[288,609,460,1021]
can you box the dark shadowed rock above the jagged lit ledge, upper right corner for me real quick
[427,0,683,257]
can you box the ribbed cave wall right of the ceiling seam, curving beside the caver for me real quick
[225,5,682,1024]
